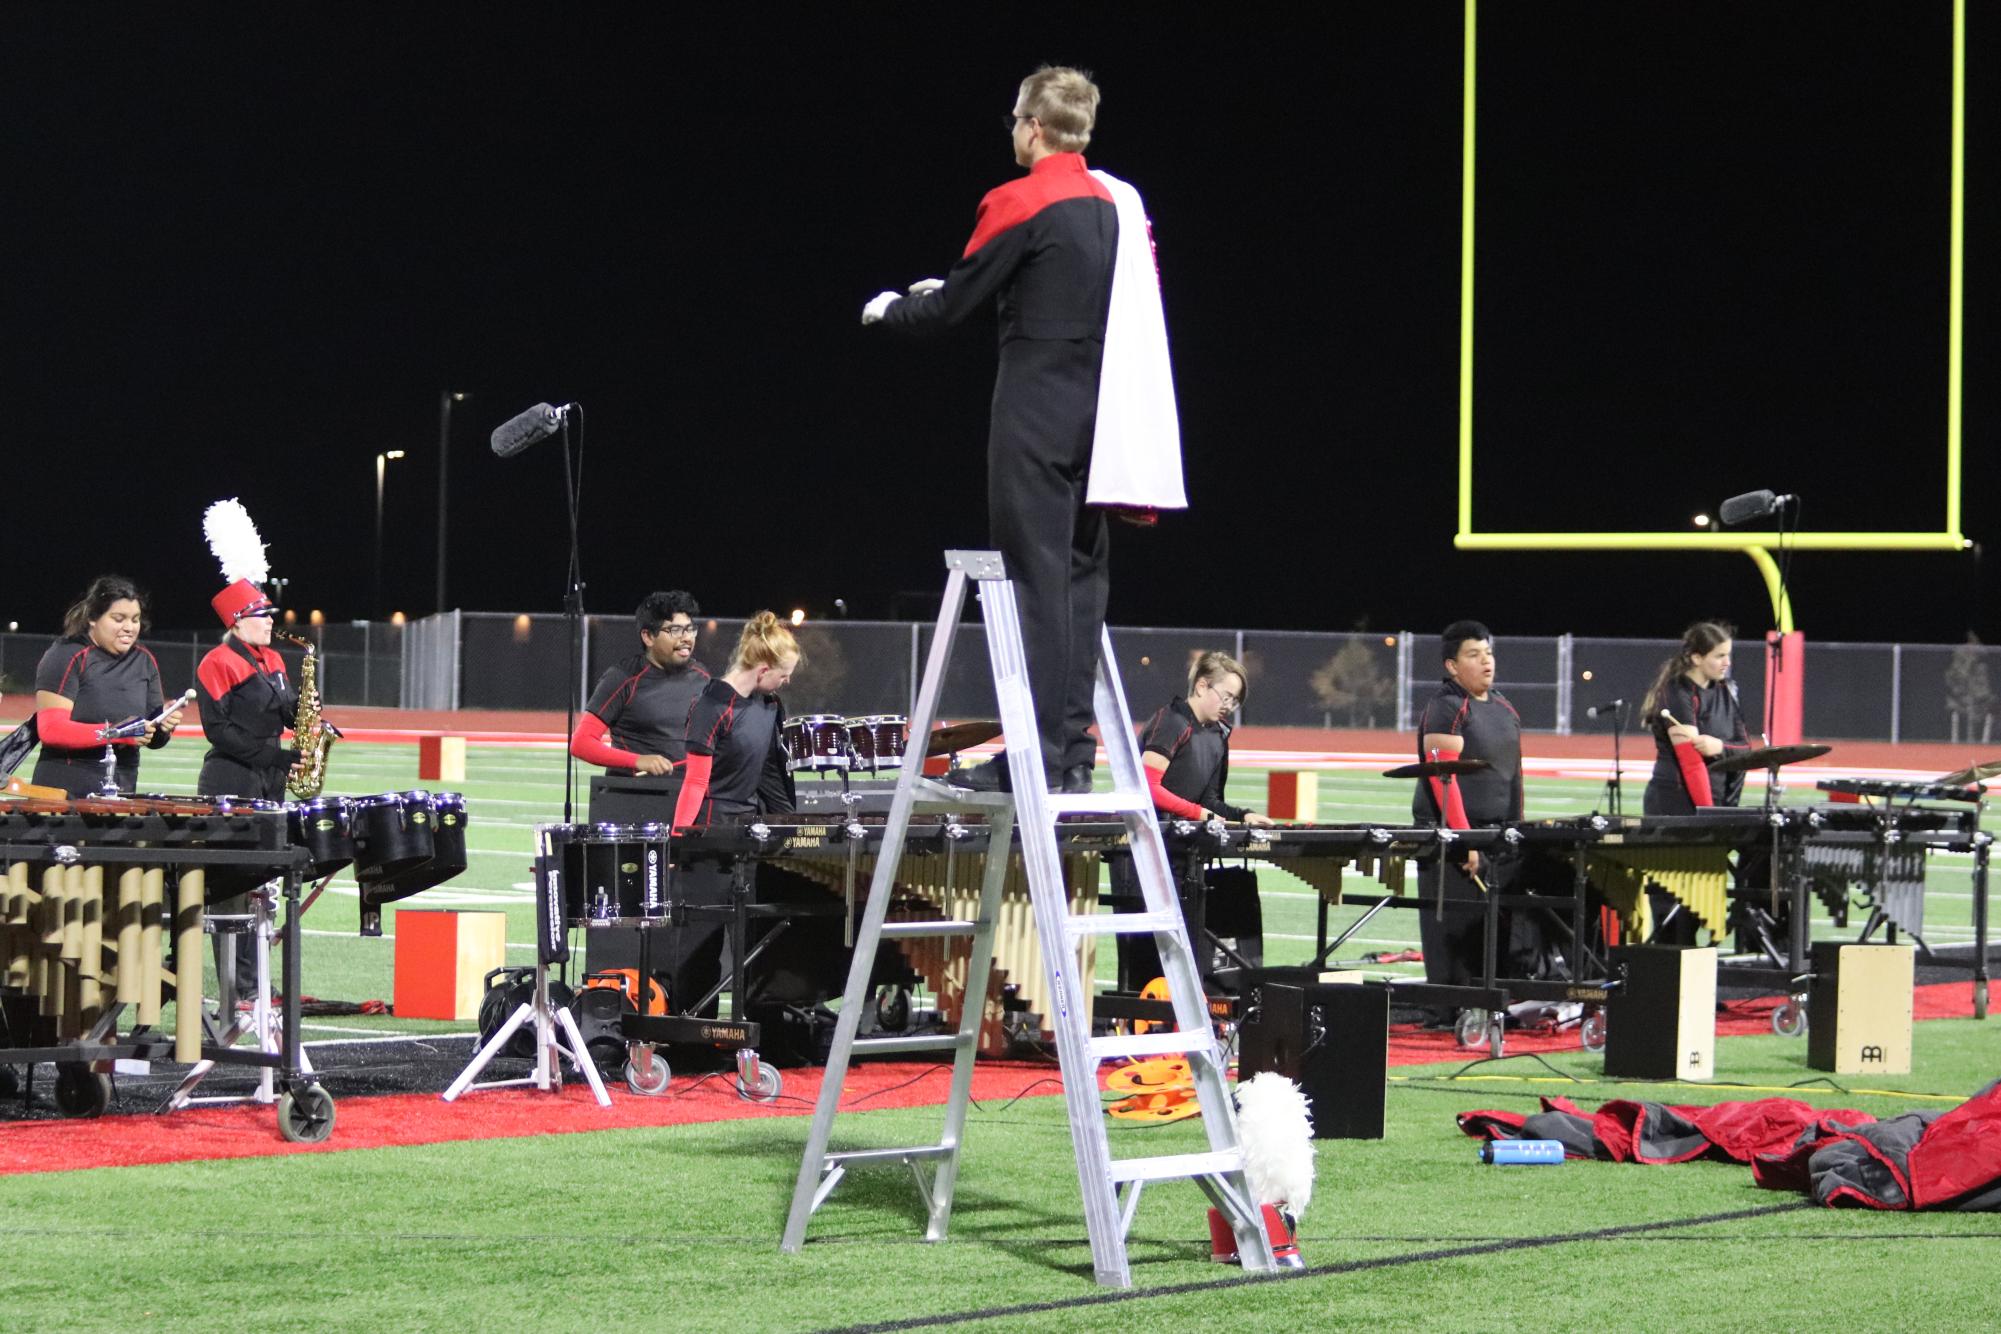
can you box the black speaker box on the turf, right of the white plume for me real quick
[1237,982,1389,1140]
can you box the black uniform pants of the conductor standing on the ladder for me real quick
[986,338,1111,774]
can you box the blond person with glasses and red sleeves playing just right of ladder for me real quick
[1107,650,1271,990]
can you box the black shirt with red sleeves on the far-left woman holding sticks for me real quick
[32,634,168,796]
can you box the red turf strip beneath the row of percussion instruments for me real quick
[0,982,1973,1174]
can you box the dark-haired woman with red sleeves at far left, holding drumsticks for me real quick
[32,574,180,798]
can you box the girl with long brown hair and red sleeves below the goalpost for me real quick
[1639,620,1751,816]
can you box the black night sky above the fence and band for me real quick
[0,0,2001,642]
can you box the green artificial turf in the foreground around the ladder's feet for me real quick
[0,1020,2001,1330]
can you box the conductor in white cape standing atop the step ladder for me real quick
[862,66,1187,792]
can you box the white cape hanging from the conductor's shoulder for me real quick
[1085,172,1189,510]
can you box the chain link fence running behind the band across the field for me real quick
[0,612,2001,744]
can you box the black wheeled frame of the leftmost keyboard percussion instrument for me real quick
[0,814,334,1144]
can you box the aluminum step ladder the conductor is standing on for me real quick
[782,552,1275,1288]
